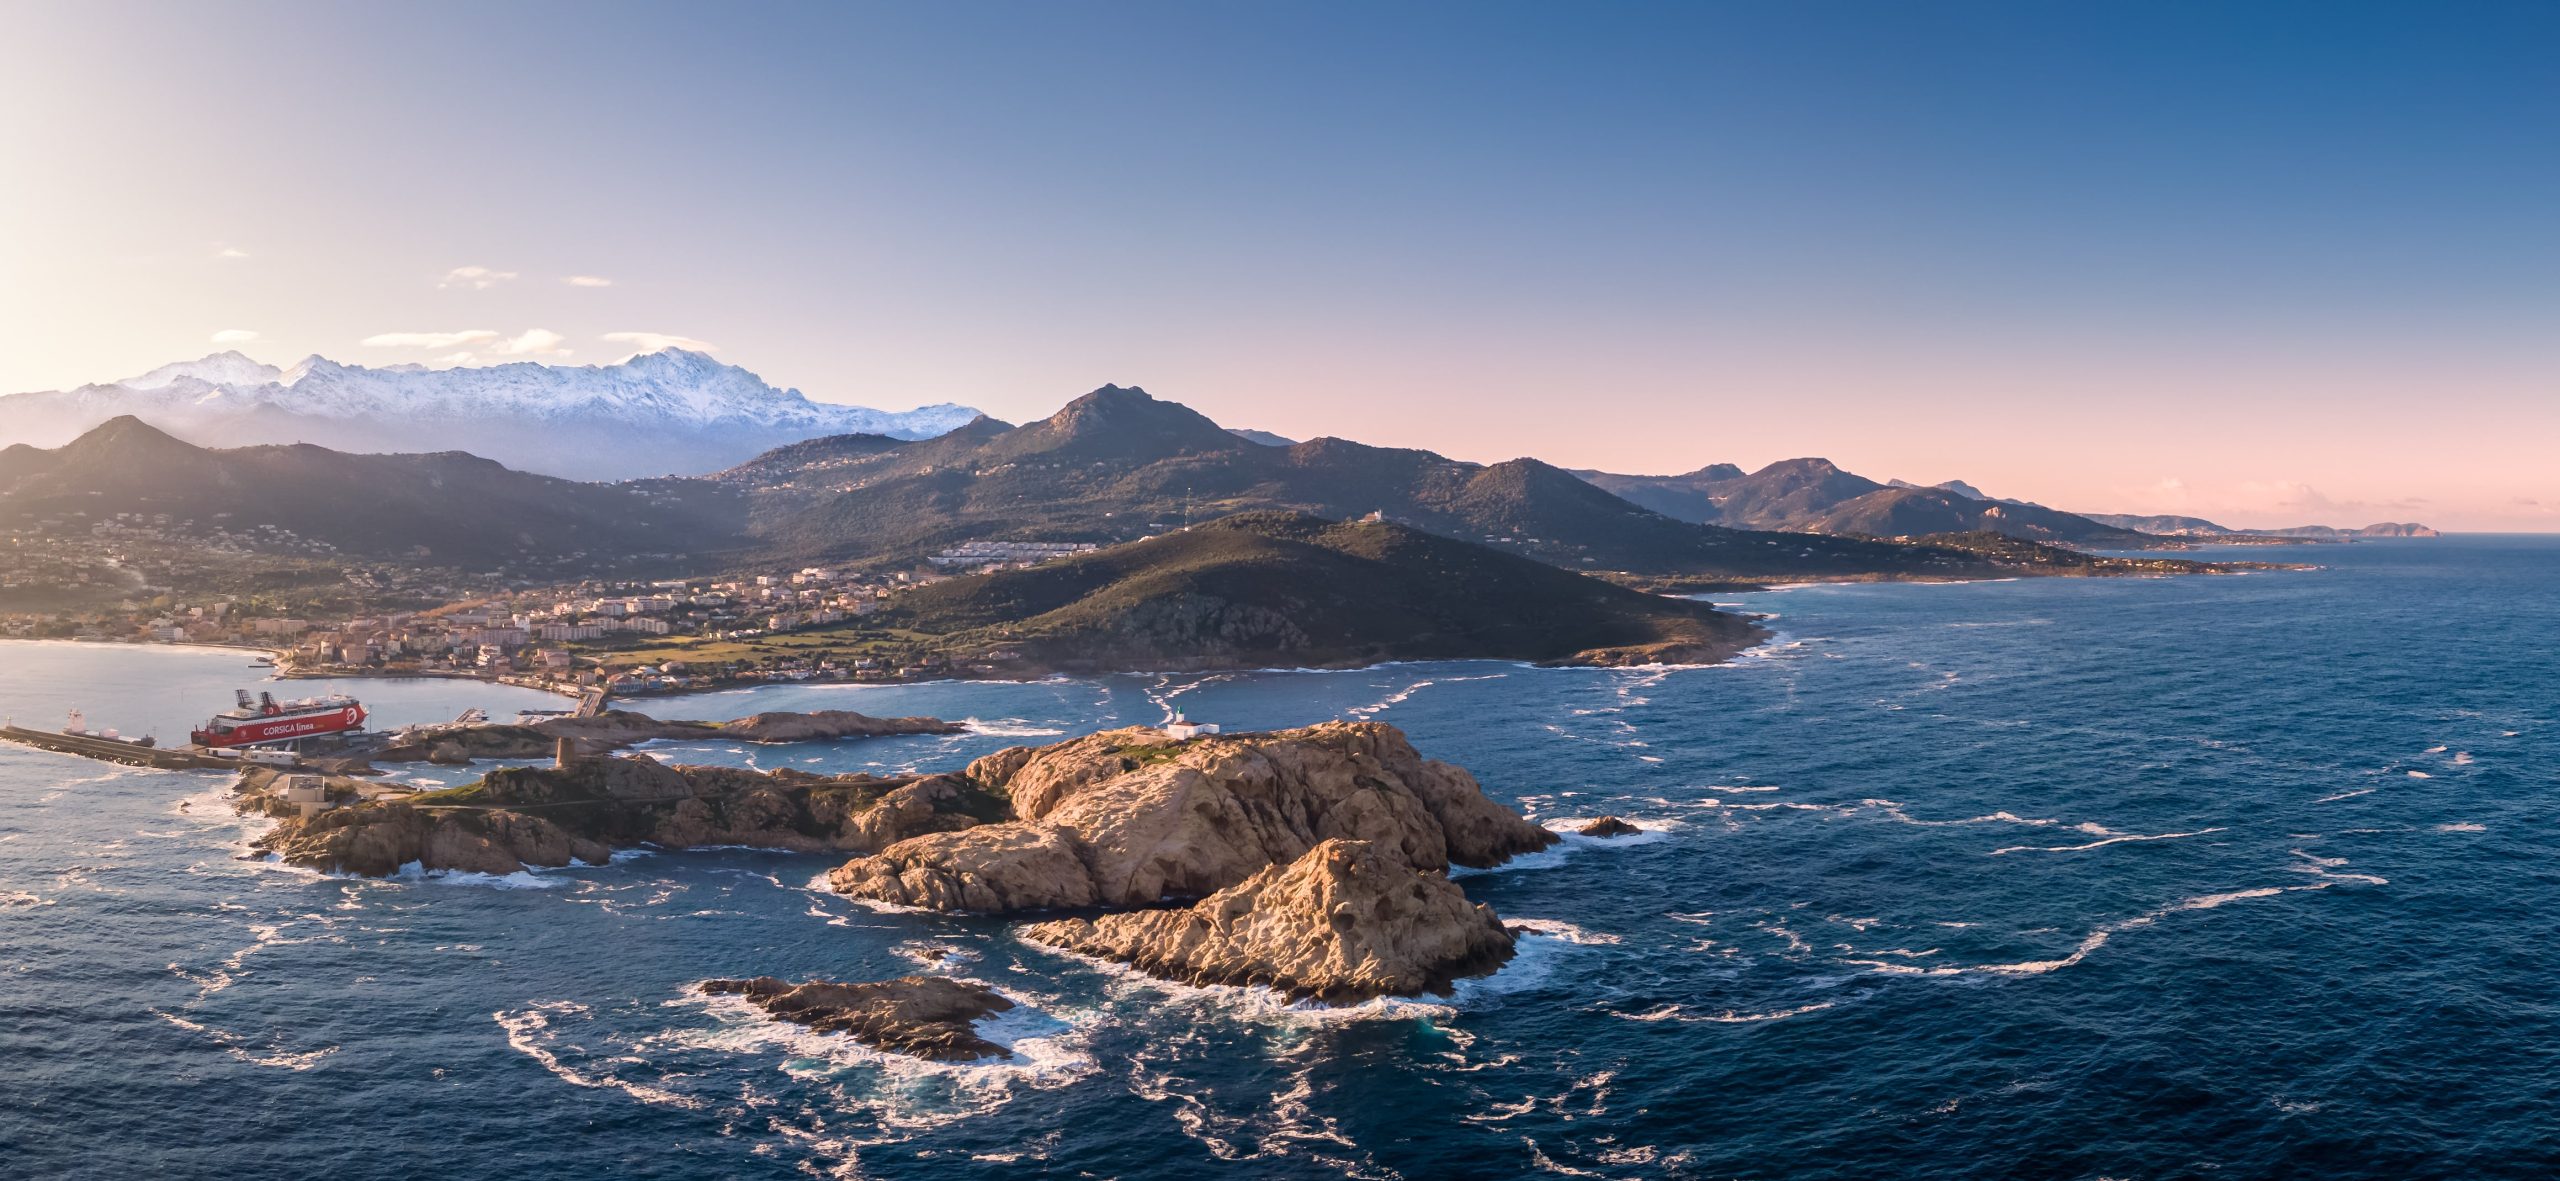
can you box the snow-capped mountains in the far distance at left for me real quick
[0,348,978,479]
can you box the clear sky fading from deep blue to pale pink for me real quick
[0,0,2560,530]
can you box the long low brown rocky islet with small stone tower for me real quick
[236,758,1004,876]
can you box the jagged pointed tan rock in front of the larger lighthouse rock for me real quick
[1021,840,1513,1002]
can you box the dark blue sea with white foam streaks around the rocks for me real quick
[0,535,2560,1181]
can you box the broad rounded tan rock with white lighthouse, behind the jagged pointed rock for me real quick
[829,722,1556,912]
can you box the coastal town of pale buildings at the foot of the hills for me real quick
[0,515,1116,697]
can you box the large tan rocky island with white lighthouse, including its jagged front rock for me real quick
[829,722,1556,1002]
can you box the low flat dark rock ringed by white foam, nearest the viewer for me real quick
[701,976,1014,1061]
